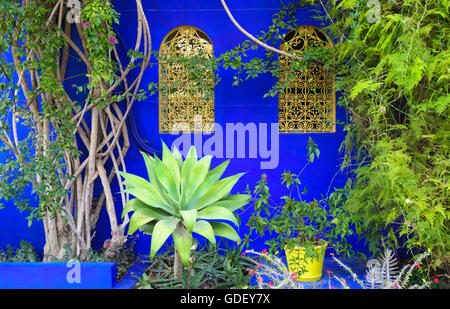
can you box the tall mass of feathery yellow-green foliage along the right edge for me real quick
[315,0,450,265]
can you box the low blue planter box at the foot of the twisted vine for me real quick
[0,262,117,289]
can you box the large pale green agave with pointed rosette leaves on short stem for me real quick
[120,143,250,277]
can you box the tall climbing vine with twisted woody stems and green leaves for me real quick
[0,0,151,260]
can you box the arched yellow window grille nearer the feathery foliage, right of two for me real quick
[278,26,336,133]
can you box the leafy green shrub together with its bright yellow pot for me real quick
[248,139,354,282]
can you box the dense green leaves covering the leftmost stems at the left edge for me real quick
[0,1,78,224]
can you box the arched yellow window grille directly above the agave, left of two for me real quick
[159,26,215,133]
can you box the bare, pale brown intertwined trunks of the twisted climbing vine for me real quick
[0,0,151,261]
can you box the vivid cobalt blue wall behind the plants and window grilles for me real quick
[0,0,366,254]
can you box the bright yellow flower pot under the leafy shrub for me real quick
[284,243,327,282]
